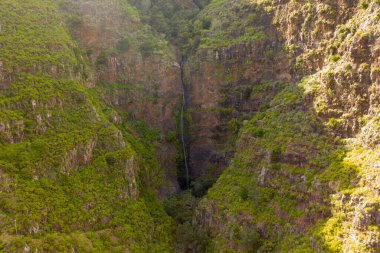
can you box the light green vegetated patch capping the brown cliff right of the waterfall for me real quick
[193,0,267,49]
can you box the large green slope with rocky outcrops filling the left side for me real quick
[0,0,172,252]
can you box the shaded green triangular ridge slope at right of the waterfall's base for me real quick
[198,81,368,252]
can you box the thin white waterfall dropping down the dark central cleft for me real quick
[180,60,190,188]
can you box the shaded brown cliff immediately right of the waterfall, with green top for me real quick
[186,1,291,175]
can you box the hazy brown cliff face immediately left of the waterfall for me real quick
[61,0,186,196]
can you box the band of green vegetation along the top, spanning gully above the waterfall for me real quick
[132,0,268,53]
